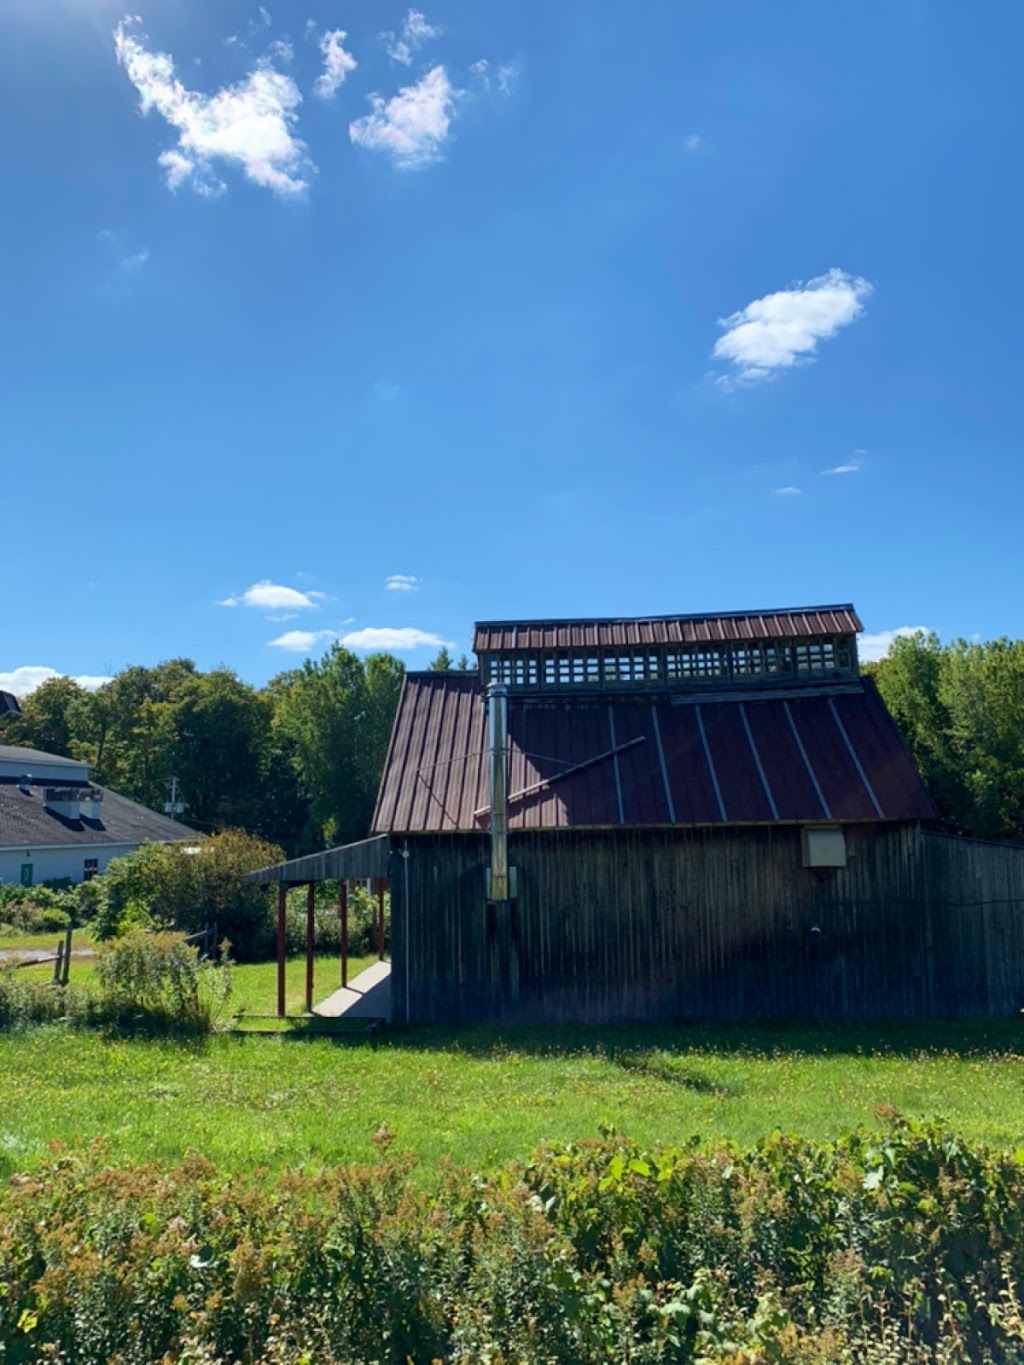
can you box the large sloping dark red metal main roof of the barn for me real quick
[373,673,937,834]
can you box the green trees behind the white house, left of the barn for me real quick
[3,646,451,857]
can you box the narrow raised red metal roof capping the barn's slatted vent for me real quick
[472,603,864,654]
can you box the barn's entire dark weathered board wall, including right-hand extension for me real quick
[392,826,1024,1021]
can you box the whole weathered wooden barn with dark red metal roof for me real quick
[254,606,1024,1022]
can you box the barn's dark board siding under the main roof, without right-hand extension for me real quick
[396,827,927,1021]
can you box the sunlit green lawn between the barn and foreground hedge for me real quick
[0,1010,1024,1179]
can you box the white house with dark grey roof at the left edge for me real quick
[0,744,197,886]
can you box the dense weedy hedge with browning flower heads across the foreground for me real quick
[0,1122,1024,1365]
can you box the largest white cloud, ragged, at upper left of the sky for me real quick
[113,18,314,195]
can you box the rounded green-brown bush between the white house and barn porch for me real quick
[90,830,284,961]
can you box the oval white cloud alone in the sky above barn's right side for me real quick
[713,269,871,388]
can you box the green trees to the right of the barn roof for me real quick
[872,635,1024,839]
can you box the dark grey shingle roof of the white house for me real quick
[0,786,197,848]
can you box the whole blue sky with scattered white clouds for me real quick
[0,0,1024,688]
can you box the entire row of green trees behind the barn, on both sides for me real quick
[4,633,1024,857]
